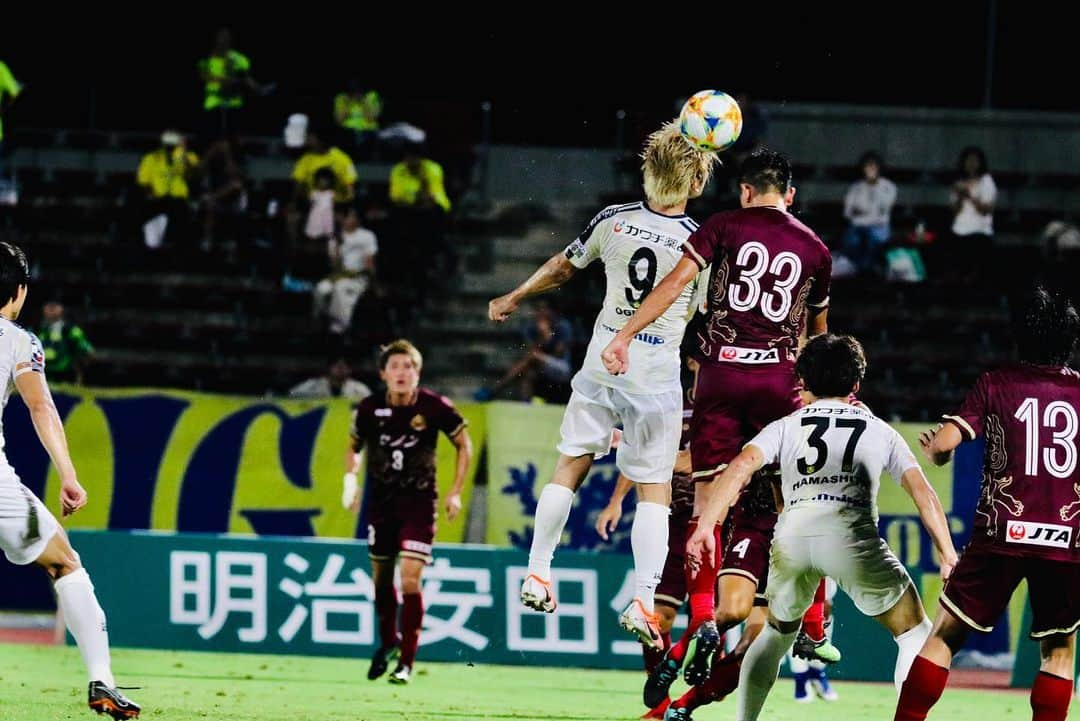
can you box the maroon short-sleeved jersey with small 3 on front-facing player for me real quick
[352,389,465,501]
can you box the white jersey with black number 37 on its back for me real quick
[747,400,919,538]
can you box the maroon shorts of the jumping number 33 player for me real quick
[690,361,802,480]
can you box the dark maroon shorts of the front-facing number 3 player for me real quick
[367,498,438,563]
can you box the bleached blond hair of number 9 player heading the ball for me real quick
[642,120,719,207]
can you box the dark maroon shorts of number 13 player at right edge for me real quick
[941,545,1080,639]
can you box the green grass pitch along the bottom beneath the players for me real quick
[0,645,1030,721]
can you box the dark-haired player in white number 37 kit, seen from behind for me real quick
[682,335,957,721]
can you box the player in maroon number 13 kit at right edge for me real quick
[895,288,1080,721]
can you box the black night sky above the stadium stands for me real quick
[0,0,1080,146]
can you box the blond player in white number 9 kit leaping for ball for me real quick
[488,122,716,648]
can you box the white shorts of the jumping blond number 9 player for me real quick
[558,373,683,484]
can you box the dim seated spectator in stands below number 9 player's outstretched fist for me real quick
[476,301,573,403]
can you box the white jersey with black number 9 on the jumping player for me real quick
[566,202,707,394]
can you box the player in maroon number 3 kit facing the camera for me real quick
[341,340,472,683]
